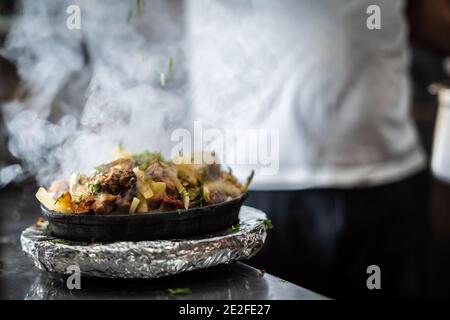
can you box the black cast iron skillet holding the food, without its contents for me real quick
[41,193,247,242]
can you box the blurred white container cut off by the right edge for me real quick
[431,83,450,183]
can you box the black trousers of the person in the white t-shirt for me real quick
[247,172,429,298]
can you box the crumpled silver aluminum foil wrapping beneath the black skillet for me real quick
[21,206,267,278]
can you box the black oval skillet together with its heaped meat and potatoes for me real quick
[36,149,253,242]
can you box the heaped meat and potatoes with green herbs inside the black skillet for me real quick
[36,148,253,215]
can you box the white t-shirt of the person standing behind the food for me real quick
[187,0,426,189]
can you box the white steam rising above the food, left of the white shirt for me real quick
[0,0,187,186]
